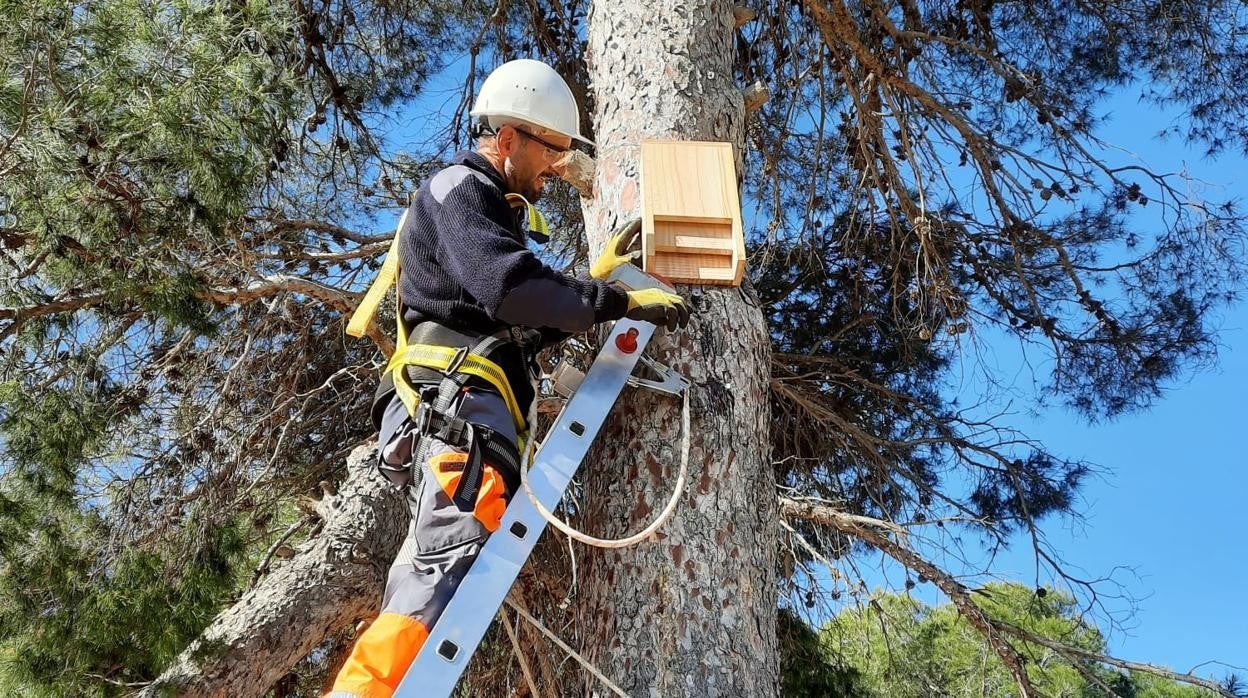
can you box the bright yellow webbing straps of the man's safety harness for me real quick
[347,204,529,435]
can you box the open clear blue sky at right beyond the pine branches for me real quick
[978,90,1248,676]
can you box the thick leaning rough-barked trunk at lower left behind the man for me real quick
[140,443,408,698]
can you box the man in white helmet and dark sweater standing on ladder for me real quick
[329,60,689,698]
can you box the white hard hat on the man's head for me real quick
[468,59,594,145]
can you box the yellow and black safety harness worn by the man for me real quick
[347,194,549,511]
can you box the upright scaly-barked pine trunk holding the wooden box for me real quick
[578,0,779,698]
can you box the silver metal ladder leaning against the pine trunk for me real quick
[394,265,689,698]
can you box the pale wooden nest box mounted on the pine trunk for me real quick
[641,141,745,286]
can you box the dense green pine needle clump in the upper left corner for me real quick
[0,0,298,332]
